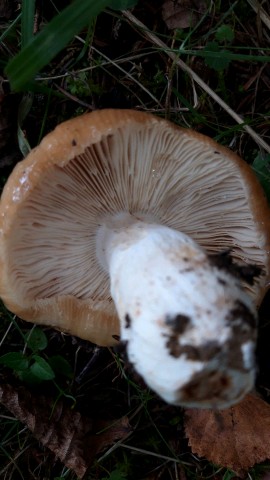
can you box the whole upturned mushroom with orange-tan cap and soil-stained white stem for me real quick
[0,110,270,408]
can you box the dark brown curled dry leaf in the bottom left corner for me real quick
[0,385,131,478]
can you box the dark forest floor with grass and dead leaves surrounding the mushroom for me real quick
[0,0,270,480]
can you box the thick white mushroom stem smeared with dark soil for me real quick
[97,214,256,408]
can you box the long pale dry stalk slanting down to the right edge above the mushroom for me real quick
[123,10,270,153]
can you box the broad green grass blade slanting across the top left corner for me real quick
[5,0,110,91]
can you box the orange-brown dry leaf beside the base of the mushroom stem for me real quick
[185,395,270,476]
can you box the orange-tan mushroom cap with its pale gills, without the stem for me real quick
[0,110,270,345]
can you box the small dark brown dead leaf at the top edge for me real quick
[162,0,207,30]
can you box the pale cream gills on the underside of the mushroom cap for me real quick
[9,124,262,299]
